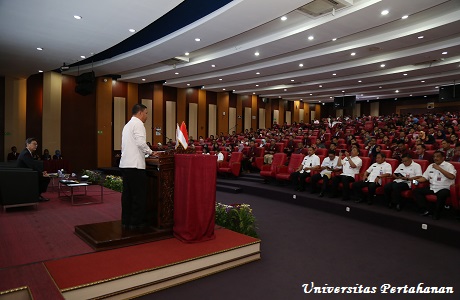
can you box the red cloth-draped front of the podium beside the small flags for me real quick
[173,154,217,243]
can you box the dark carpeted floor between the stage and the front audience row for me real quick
[146,192,460,300]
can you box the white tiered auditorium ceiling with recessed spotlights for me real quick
[0,0,460,103]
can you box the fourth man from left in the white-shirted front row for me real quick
[352,153,393,205]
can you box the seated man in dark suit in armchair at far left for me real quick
[16,138,50,202]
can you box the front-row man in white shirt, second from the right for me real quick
[383,153,422,211]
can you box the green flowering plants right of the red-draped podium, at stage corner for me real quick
[216,203,257,237]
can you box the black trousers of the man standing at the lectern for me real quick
[120,168,147,226]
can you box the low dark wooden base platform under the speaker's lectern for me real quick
[75,220,173,251]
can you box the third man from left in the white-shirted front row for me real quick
[331,147,363,201]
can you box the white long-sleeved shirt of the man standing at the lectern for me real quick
[120,117,153,169]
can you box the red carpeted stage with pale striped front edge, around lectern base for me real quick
[0,187,260,300]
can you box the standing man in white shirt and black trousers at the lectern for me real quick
[120,104,156,230]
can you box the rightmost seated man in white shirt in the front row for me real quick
[414,150,457,220]
